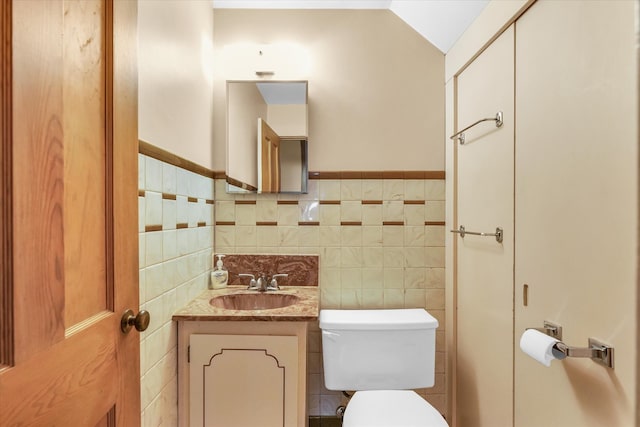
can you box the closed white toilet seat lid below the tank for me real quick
[342,390,448,427]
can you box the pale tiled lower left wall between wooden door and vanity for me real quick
[138,155,214,427]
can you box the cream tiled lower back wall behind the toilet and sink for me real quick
[214,179,445,416]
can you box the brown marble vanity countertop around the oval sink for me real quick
[173,286,319,322]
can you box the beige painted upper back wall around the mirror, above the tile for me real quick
[214,9,444,171]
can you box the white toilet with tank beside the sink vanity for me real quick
[320,309,448,427]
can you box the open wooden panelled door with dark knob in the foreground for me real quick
[0,0,140,426]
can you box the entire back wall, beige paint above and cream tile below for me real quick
[214,9,445,415]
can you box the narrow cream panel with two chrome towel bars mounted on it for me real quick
[451,28,514,427]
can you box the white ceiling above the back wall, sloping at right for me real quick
[213,0,489,53]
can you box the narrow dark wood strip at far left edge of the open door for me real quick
[0,1,13,368]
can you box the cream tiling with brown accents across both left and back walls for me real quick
[138,162,445,427]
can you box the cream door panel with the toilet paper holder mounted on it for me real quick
[515,1,638,427]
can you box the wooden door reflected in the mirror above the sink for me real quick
[258,119,280,193]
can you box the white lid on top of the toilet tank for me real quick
[320,308,438,330]
